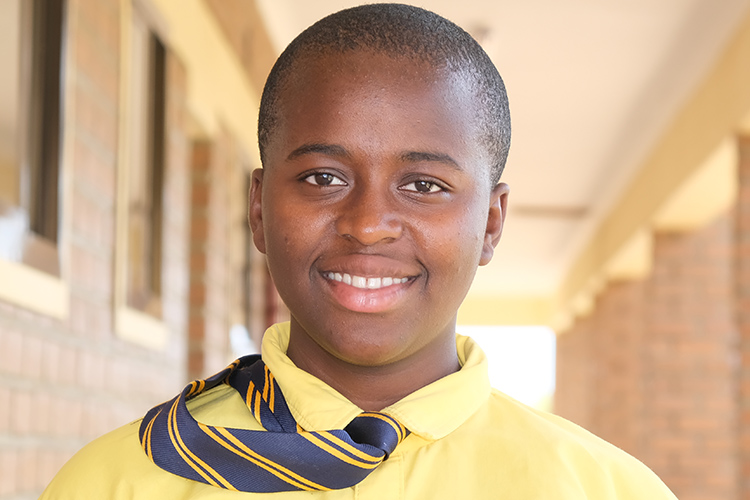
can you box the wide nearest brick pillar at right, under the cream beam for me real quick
[642,219,737,500]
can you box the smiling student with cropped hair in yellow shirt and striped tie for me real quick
[42,4,674,500]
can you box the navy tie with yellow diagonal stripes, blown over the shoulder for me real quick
[139,355,409,493]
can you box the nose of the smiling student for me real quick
[336,187,403,246]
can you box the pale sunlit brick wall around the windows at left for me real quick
[0,0,188,500]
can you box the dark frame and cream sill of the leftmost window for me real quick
[0,0,74,319]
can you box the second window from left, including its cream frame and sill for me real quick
[114,0,169,350]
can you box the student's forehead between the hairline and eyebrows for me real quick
[272,50,483,167]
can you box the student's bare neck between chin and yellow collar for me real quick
[287,324,461,411]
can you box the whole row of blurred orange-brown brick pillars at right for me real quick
[555,214,739,500]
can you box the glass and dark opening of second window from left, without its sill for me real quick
[126,10,166,317]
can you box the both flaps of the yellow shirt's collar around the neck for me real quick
[261,323,491,440]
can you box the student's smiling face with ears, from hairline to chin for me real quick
[250,51,507,376]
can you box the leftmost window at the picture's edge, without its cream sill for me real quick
[0,0,66,276]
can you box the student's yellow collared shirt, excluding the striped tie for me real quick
[41,324,675,500]
